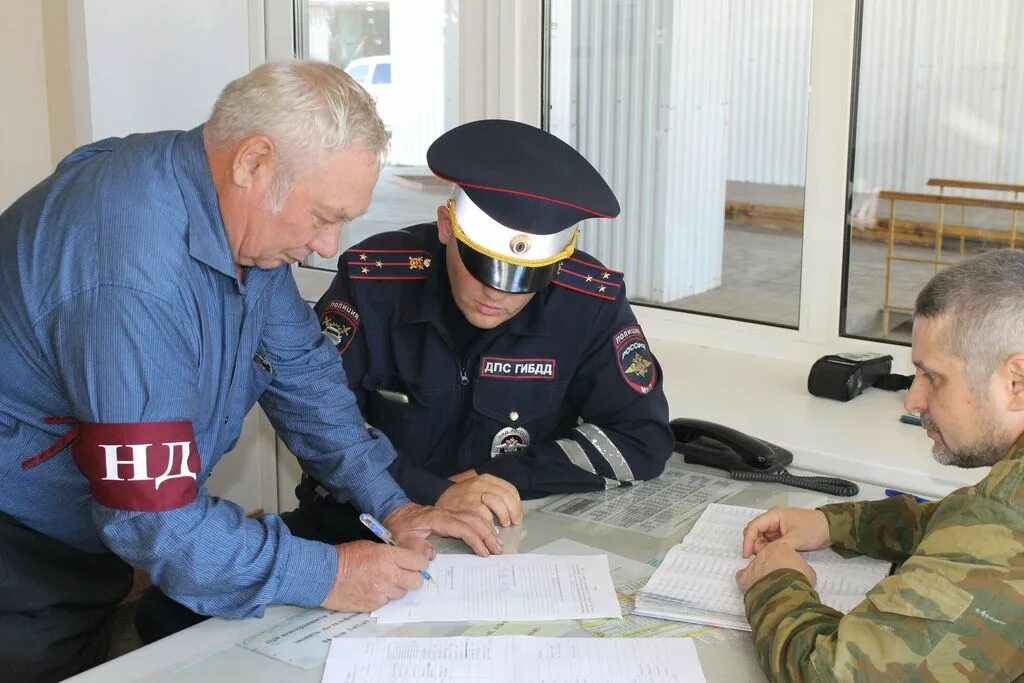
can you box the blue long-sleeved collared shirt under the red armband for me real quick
[0,129,408,617]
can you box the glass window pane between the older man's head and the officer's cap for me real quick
[303,0,459,270]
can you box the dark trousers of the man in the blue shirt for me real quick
[0,512,132,682]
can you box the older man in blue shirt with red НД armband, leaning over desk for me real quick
[0,62,501,680]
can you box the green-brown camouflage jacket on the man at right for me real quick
[744,436,1024,683]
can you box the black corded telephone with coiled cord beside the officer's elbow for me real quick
[669,418,860,496]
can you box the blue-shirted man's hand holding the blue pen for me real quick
[321,541,429,612]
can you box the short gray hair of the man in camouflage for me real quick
[913,249,1024,392]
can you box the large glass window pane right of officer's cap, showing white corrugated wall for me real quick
[547,0,812,327]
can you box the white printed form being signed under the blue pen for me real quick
[372,554,622,624]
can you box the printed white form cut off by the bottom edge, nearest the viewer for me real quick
[323,636,705,683]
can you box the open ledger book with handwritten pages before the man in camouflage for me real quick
[634,503,890,631]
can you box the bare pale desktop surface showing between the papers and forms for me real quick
[72,468,901,683]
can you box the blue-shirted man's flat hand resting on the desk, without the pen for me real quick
[384,503,502,559]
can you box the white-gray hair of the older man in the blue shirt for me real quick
[203,61,388,208]
